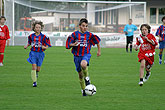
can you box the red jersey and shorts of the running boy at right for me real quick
[136,34,158,65]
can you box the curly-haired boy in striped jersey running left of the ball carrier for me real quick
[24,21,51,87]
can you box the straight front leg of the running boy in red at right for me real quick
[139,59,145,86]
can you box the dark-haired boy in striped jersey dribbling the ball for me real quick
[66,18,101,96]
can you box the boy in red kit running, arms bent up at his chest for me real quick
[135,24,158,86]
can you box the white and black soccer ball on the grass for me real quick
[85,84,96,96]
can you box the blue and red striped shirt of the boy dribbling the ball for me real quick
[66,31,101,56]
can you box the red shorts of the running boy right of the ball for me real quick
[138,53,155,68]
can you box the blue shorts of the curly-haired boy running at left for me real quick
[27,51,45,66]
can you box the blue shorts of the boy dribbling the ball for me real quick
[74,54,91,72]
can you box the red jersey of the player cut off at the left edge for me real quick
[0,25,10,40]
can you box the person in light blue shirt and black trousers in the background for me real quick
[124,19,137,52]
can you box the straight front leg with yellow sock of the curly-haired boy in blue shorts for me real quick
[31,64,37,87]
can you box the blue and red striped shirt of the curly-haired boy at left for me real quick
[28,33,51,52]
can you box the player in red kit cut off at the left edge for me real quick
[0,16,10,66]
